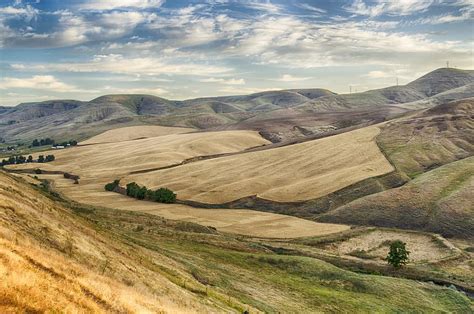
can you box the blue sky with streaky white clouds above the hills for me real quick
[0,0,474,106]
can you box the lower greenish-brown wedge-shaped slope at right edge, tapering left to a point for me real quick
[319,157,474,239]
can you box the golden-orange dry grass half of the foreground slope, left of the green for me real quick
[0,172,236,313]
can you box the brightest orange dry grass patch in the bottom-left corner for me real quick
[0,239,173,313]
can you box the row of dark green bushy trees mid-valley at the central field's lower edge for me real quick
[104,180,176,203]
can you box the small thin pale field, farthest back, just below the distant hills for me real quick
[80,125,194,145]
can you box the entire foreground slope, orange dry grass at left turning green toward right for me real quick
[0,172,472,313]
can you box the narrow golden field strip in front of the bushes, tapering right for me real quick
[33,175,349,238]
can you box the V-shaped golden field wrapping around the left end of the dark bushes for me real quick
[11,131,349,238]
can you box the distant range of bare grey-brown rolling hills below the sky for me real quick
[0,68,474,142]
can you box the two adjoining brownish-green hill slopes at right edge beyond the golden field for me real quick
[319,98,474,238]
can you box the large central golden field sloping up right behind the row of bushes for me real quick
[126,126,393,204]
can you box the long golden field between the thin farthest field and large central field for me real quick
[12,131,269,182]
